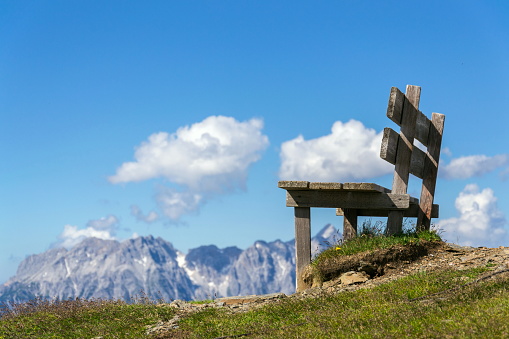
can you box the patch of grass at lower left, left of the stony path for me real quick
[0,299,175,339]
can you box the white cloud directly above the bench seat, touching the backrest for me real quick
[279,120,394,182]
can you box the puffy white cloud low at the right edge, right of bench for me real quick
[438,184,509,247]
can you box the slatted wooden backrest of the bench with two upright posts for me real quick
[380,85,445,229]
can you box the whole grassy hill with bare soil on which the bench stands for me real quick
[0,232,509,339]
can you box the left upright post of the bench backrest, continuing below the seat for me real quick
[387,85,421,234]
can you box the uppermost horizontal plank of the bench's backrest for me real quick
[387,86,431,146]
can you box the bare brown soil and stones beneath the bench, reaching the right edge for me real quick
[293,242,509,298]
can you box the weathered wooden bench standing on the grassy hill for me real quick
[278,85,445,291]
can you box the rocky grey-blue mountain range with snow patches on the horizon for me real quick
[0,225,340,302]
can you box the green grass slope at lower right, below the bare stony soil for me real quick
[176,268,509,338]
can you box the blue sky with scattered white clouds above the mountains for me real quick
[0,1,509,282]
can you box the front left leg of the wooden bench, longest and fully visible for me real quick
[295,207,311,292]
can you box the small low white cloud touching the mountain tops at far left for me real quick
[56,215,119,248]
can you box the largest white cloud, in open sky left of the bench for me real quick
[109,116,269,220]
